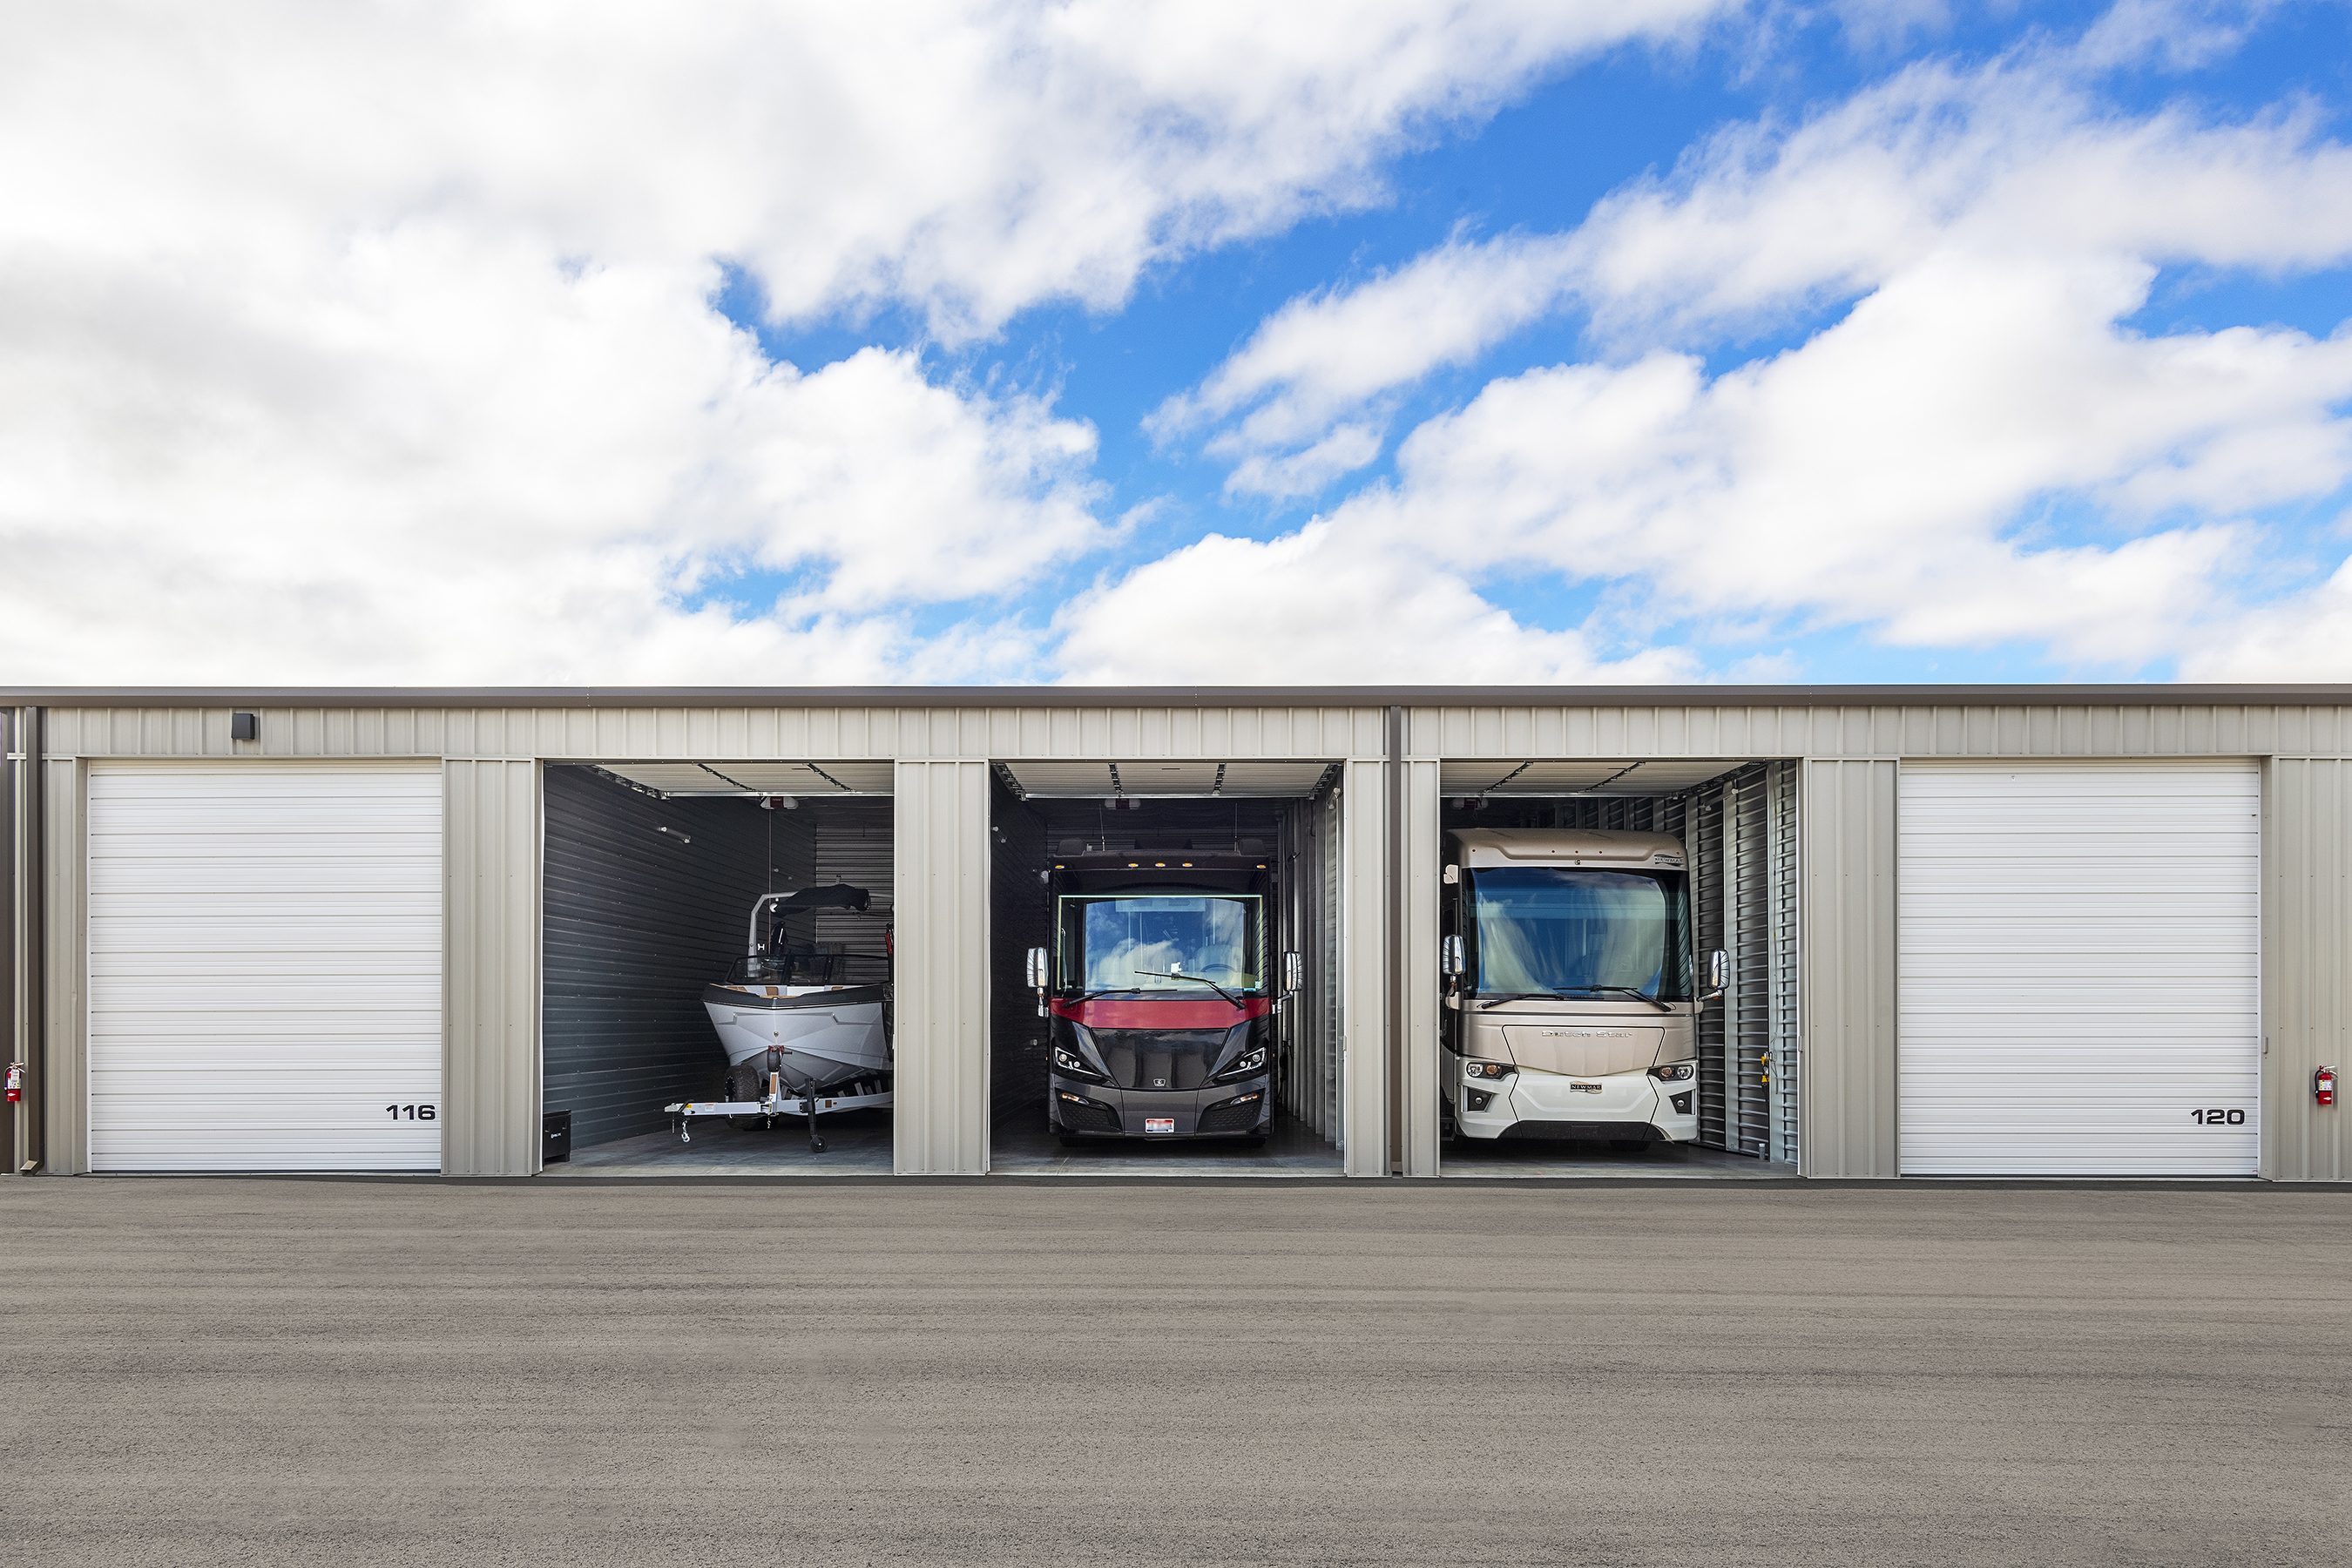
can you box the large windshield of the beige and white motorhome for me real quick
[1470,865,1691,1002]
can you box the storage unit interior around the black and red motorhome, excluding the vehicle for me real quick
[990,760,1343,1175]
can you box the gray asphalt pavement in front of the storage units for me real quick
[0,1178,2352,1568]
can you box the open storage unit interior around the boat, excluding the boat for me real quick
[541,761,891,1175]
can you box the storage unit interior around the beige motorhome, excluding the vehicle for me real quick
[1439,757,1800,1178]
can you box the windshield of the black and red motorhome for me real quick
[1058,893,1266,992]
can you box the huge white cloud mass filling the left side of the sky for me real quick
[0,0,1724,682]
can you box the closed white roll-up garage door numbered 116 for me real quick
[90,761,443,1171]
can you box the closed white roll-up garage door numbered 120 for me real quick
[1896,761,2262,1175]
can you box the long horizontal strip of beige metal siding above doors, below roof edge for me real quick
[50,693,2352,761]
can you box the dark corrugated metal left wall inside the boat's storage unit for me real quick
[541,767,771,1147]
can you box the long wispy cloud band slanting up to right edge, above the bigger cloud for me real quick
[1185,37,2352,510]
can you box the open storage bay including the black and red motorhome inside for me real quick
[990,760,1343,1175]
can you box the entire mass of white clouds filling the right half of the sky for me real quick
[1114,25,2352,677]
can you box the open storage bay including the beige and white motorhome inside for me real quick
[1437,757,1800,1178]
